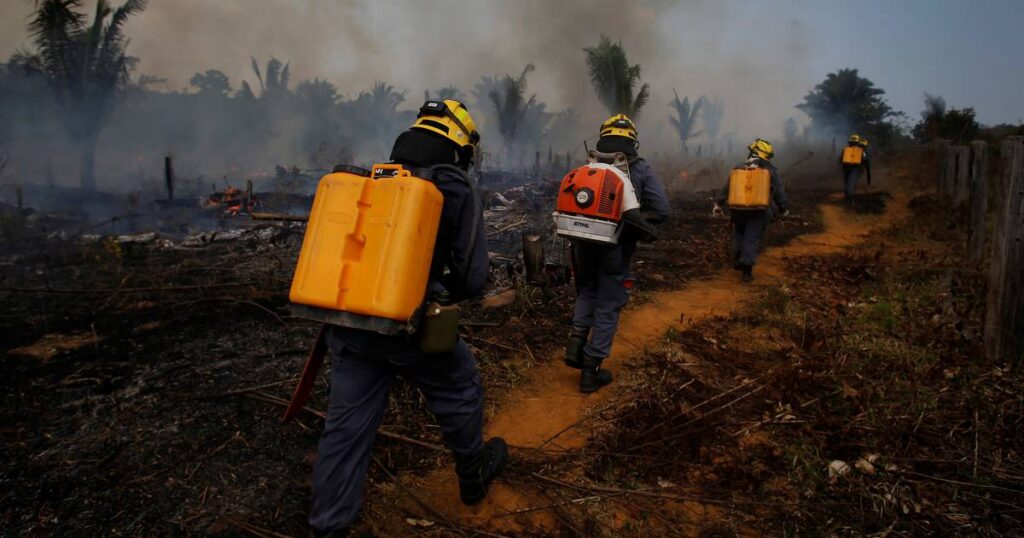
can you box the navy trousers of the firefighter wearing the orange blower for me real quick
[572,241,633,359]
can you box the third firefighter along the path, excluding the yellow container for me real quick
[713,138,790,282]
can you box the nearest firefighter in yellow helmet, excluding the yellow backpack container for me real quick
[309,99,508,536]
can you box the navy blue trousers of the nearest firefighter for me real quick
[309,327,483,532]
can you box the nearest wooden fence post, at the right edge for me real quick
[985,139,1024,362]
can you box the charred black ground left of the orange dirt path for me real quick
[0,183,819,535]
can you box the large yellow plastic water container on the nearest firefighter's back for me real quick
[289,164,444,334]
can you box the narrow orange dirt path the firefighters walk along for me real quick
[391,183,907,533]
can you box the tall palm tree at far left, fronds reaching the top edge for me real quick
[19,0,146,191]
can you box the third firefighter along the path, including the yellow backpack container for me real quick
[713,138,788,282]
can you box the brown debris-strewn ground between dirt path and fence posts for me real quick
[499,176,1024,536]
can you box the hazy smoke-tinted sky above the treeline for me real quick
[0,0,1024,132]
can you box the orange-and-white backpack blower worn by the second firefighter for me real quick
[552,151,643,245]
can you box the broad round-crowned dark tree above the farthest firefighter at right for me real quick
[797,69,900,138]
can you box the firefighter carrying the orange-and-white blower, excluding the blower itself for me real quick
[565,114,670,394]
